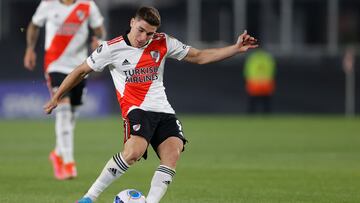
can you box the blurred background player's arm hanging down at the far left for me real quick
[24,22,40,70]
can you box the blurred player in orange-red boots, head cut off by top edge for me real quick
[24,0,105,180]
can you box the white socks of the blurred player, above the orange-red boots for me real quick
[55,104,74,163]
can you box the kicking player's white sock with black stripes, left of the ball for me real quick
[85,153,130,201]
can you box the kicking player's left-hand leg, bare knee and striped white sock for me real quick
[78,136,148,203]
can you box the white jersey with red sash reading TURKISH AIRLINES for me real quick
[86,33,190,118]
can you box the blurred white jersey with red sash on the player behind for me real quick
[32,0,103,74]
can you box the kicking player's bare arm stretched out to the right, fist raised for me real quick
[184,31,258,64]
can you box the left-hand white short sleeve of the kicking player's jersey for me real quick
[86,41,112,72]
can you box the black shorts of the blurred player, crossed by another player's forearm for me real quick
[47,73,86,106]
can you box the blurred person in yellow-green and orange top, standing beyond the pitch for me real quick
[244,49,276,113]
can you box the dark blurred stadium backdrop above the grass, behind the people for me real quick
[0,0,360,118]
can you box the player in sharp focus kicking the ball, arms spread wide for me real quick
[44,7,258,203]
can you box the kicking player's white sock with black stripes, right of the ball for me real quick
[146,165,175,203]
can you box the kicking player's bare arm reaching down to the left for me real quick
[44,61,93,114]
